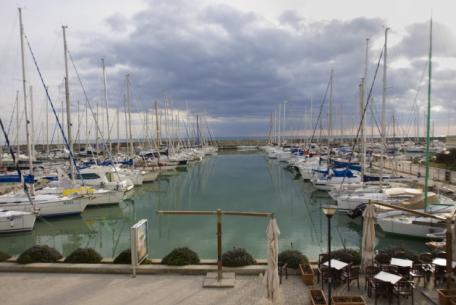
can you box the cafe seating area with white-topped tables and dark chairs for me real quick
[306,247,456,305]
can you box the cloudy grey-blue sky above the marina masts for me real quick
[0,0,456,139]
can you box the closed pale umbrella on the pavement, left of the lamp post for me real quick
[265,218,280,303]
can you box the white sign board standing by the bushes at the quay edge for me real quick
[130,219,149,277]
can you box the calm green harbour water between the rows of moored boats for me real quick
[0,153,425,258]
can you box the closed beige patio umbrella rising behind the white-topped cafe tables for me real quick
[361,203,376,268]
